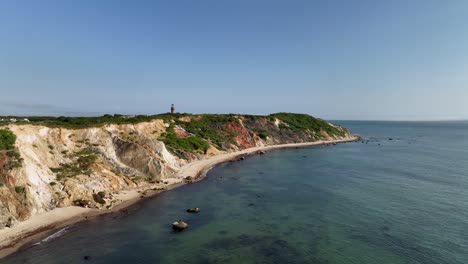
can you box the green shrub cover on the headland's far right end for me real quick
[270,113,344,136]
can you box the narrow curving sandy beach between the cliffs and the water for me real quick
[0,136,359,259]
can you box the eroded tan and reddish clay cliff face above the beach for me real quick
[0,115,350,229]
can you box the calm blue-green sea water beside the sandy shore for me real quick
[0,122,468,264]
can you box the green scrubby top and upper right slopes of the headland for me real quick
[0,113,346,156]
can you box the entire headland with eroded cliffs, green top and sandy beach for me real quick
[0,113,357,256]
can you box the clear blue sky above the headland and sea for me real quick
[0,0,468,120]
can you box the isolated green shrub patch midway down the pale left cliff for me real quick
[50,148,98,181]
